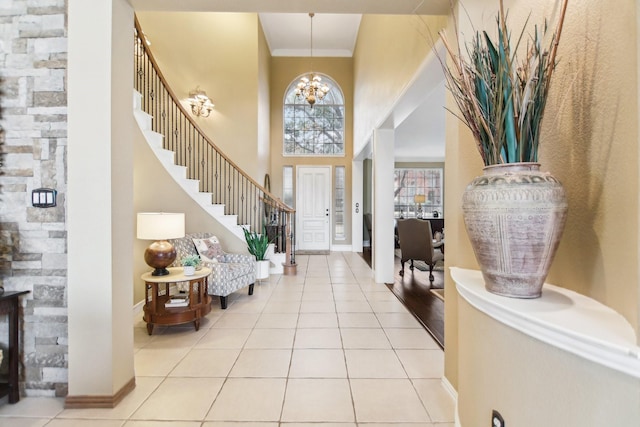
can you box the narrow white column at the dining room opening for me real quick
[372,129,395,283]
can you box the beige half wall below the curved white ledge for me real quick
[458,301,640,427]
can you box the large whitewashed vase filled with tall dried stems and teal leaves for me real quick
[440,0,567,298]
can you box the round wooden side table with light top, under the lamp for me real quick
[142,267,211,335]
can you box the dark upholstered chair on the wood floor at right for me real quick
[398,218,444,283]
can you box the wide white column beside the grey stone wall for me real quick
[66,0,135,399]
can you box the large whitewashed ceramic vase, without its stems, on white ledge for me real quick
[462,163,567,298]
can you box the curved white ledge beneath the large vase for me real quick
[451,267,640,378]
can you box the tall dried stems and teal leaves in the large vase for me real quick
[440,0,568,166]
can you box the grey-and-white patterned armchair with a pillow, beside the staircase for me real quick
[170,232,256,309]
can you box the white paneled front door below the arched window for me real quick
[296,166,331,251]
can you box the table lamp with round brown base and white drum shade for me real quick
[137,212,184,276]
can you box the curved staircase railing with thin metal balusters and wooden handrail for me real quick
[134,18,296,274]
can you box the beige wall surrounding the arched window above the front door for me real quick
[271,57,353,245]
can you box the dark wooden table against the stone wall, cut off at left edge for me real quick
[0,291,30,403]
